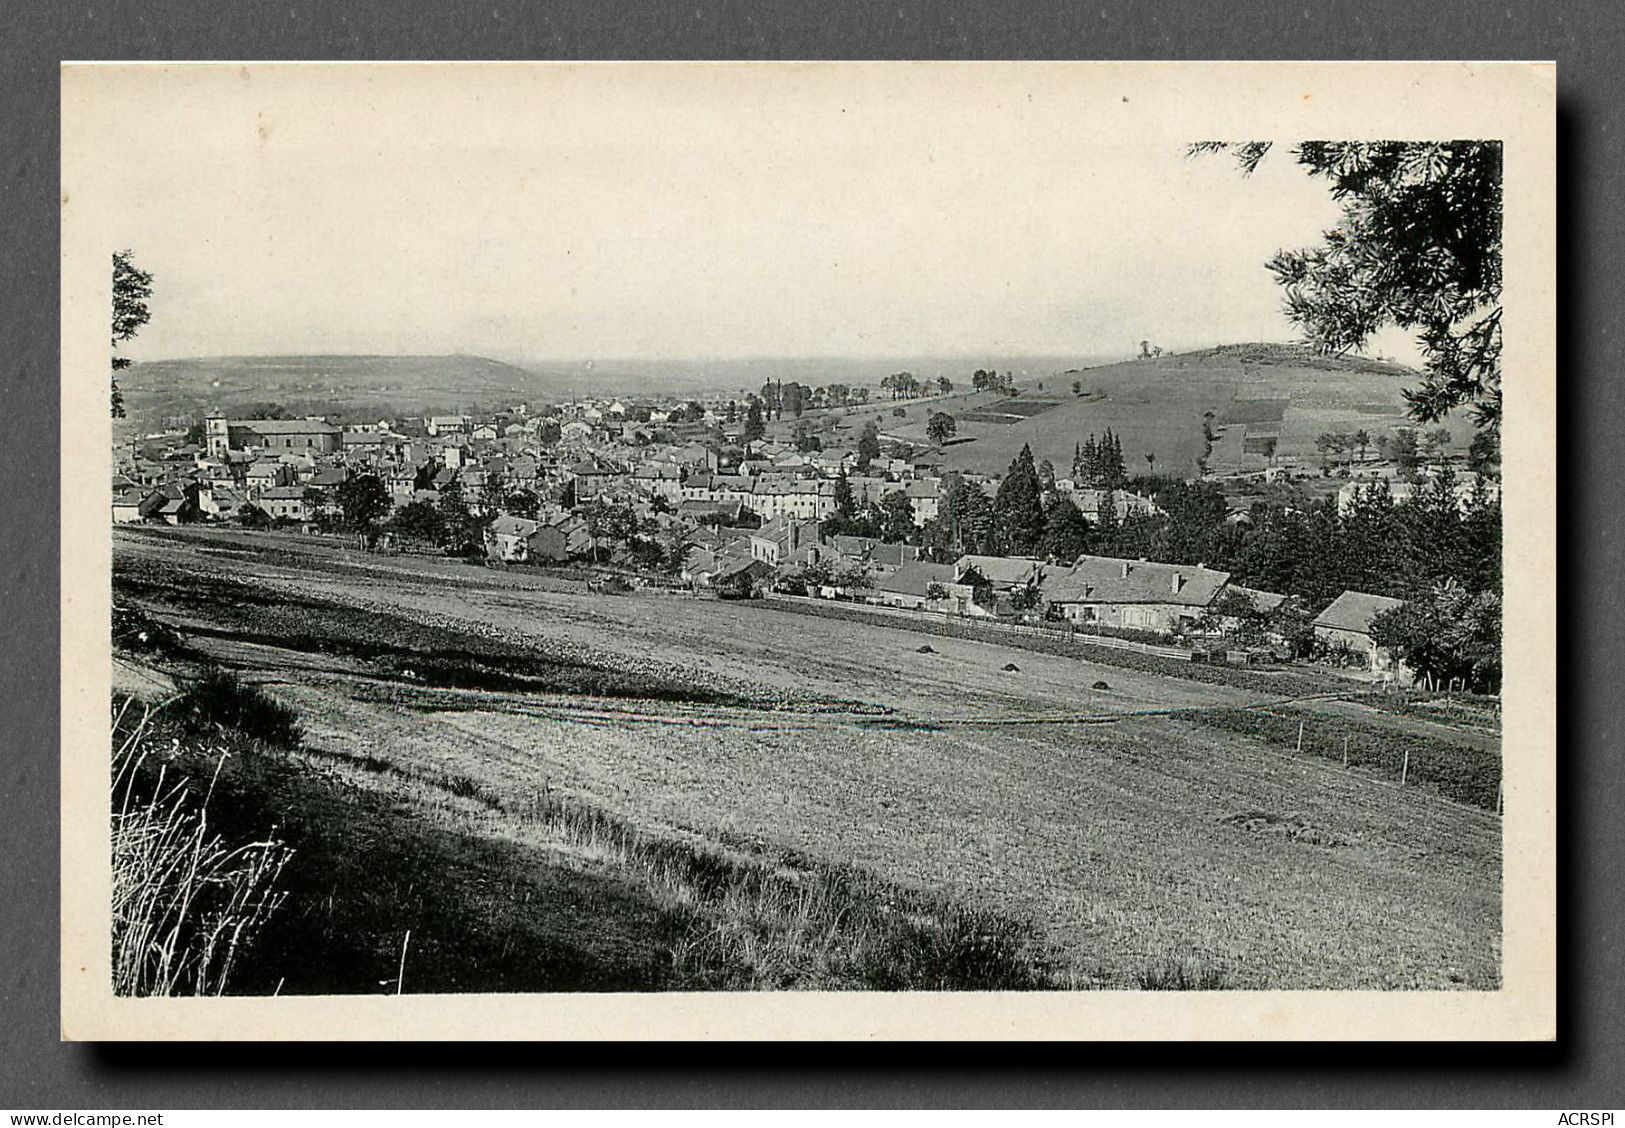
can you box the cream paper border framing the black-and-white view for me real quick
[62,62,1557,1040]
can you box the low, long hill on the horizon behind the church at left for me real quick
[119,354,561,429]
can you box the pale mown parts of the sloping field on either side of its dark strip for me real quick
[119,536,1500,987]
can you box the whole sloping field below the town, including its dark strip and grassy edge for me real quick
[115,530,1500,991]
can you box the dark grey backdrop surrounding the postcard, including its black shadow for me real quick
[0,0,1625,1110]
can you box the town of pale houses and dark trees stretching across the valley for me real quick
[112,362,1500,691]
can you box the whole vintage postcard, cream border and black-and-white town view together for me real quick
[62,63,1554,1037]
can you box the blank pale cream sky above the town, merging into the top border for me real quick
[63,65,1423,361]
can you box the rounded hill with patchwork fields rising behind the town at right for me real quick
[840,343,1472,476]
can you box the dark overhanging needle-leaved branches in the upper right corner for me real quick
[1191,141,1502,431]
